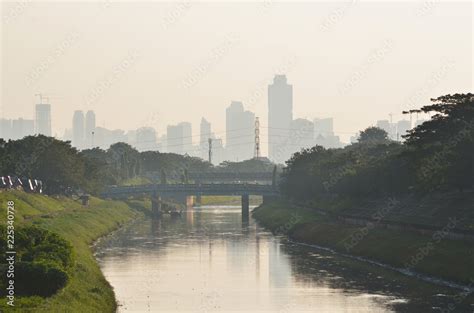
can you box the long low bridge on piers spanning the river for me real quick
[102,183,278,216]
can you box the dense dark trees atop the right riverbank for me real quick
[281,94,474,200]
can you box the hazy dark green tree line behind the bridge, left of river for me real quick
[0,135,280,194]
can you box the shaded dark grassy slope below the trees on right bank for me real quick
[253,201,474,286]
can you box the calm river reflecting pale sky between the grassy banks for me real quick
[96,206,470,313]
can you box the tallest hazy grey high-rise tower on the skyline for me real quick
[268,75,293,163]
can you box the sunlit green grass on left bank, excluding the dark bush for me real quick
[0,192,148,312]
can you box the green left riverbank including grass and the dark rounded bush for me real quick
[0,191,149,312]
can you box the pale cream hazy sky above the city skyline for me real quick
[1,1,474,148]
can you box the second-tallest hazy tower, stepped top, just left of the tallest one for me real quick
[225,101,255,161]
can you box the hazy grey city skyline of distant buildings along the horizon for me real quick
[0,74,422,164]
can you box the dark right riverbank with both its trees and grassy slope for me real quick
[253,94,474,290]
